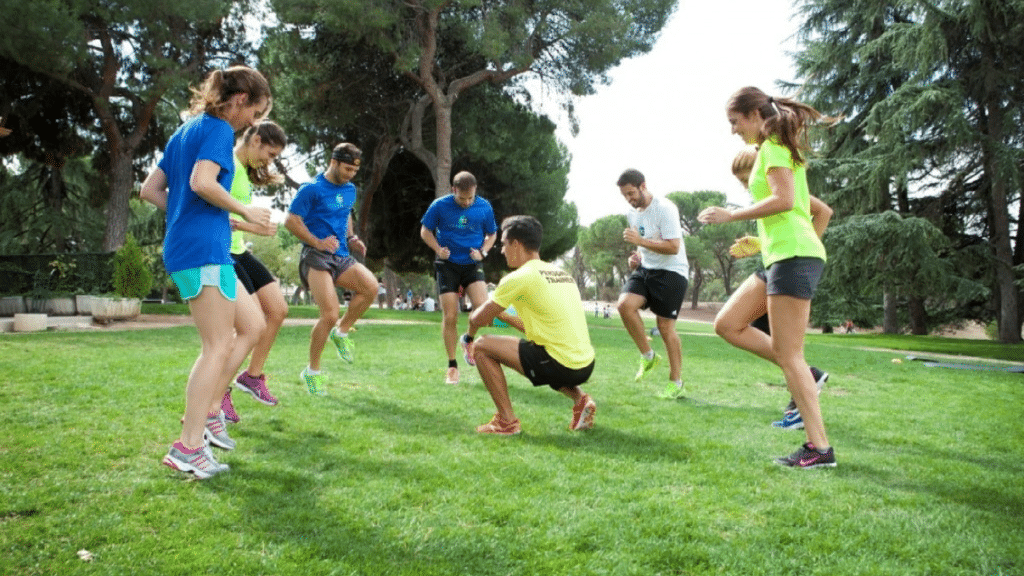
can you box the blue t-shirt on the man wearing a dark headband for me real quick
[288,174,355,256]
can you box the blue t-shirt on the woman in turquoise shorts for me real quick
[159,114,234,273]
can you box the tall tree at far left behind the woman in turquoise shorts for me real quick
[0,0,252,250]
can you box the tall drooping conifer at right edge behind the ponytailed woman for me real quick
[798,0,1024,342]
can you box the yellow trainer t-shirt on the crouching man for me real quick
[492,260,594,370]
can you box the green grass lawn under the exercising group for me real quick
[0,308,1024,576]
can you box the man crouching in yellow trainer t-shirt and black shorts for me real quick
[462,216,597,435]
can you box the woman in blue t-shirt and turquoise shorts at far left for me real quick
[141,66,271,479]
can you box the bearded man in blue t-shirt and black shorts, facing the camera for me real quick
[420,172,498,384]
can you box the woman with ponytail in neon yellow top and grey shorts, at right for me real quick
[698,87,836,467]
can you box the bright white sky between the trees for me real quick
[539,0,799,224]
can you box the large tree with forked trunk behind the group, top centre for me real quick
[272,0,675,197]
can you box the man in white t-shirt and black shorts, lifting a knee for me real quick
[617,169,689,399]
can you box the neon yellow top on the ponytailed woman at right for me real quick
[750,139,825,266]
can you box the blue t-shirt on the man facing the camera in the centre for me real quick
[420,194,498,264]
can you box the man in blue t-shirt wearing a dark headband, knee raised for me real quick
[285,142,377,396]
